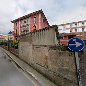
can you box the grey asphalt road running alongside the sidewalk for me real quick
[0,49,37,86]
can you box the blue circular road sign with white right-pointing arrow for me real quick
[68,38,84,52]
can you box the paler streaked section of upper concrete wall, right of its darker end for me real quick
[32,29,55,45]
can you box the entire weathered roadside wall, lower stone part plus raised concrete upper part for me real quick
[19,28,77,86]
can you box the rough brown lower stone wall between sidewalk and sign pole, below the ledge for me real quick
[20,43,77,86]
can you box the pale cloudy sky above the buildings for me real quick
[0,0,86,34]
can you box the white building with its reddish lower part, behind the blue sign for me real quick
[58,20,86,45]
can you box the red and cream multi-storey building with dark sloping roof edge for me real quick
[11,10,49,40]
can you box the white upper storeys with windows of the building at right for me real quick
[58,20,86,33]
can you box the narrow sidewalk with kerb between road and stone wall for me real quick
[1,48,57,86]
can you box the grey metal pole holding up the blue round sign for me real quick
[75,52,82,86]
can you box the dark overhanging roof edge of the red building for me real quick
[11,9,49,25]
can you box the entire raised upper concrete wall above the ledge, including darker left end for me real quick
[20,28,58,46]
